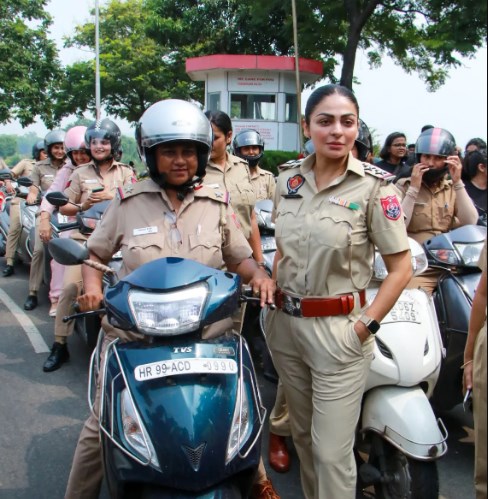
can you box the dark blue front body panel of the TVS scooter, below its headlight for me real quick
[101,334,260,497]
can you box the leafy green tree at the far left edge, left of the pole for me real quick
[0,0,62,128]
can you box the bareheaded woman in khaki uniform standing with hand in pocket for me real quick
[267,85,412,499]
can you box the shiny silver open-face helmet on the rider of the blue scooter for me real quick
[136,99,213,183]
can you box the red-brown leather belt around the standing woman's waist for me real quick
[275,288,366,317]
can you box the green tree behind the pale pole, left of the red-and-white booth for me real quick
[56,0,197,122]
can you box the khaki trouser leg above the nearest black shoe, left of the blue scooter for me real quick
[54,265,83,343]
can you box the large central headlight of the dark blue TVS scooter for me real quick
[129,284,208,336]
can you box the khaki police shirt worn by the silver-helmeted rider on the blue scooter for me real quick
[87,179,252,277]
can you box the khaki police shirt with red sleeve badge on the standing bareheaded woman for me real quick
[274,154,409,296]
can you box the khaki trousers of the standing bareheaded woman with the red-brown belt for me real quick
[266,310,373,499]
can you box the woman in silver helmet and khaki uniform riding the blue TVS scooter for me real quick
[65,100,275,499]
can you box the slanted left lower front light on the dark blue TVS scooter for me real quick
[120,388,161,469]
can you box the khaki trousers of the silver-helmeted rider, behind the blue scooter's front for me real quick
[65,318,267,499]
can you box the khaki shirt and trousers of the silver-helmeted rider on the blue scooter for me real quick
[65,179,252,499]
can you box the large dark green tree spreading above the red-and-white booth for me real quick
[146,0,487,90]
